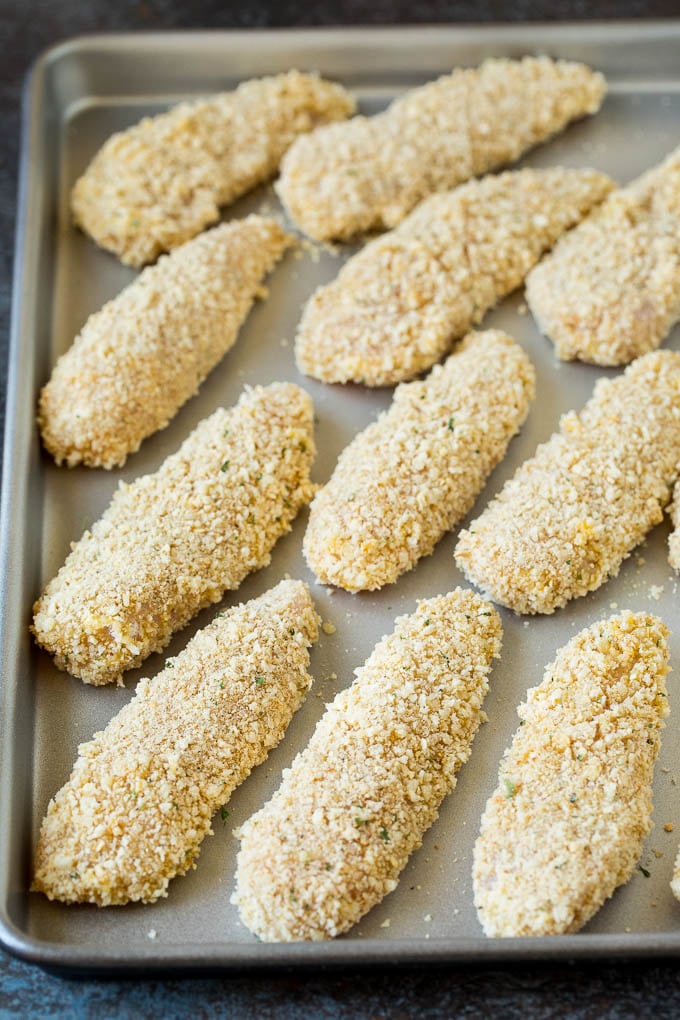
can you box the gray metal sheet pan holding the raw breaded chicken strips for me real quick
[0,22,680,973]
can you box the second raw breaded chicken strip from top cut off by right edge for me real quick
[456,351,680,613]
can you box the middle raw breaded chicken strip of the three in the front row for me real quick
[232,589,502,941]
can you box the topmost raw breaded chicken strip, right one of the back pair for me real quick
[276,57,606,241]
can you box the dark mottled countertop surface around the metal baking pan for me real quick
[0,0,680,1020]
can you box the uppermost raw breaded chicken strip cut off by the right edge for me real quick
[526,149,680,365]
